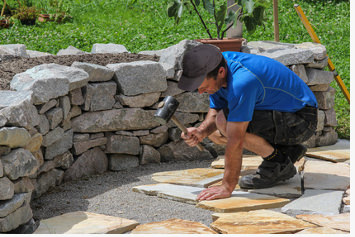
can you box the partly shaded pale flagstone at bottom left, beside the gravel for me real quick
[34,211,139,234]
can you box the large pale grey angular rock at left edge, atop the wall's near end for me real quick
[0,91,39,129]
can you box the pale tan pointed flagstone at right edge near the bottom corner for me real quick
[296,213,350,231]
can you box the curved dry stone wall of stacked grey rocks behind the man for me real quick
[0,40,337,232]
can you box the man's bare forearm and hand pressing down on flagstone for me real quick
[197,122,249,200]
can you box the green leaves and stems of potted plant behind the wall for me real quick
[167,0,268,39]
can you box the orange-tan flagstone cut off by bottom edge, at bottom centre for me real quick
[131,219,216,234]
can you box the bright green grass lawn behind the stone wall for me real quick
[0,0,350,139]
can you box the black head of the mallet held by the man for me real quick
[154,96,179,125]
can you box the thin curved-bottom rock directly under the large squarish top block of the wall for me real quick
[117,92,160,108]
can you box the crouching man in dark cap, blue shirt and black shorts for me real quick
[178,44,318,200]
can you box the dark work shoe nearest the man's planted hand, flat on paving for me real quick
[239,157,297,189]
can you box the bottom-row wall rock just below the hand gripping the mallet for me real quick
[158,141,213,161]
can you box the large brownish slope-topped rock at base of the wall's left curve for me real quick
[64,147,108,181]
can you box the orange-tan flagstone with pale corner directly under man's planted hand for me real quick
[196,191,290,212]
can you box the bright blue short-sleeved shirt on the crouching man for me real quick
[210,52,318,122]
